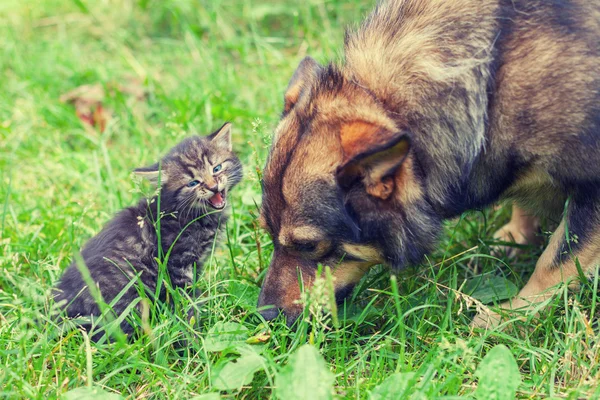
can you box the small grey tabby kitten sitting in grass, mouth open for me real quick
[53,123,242,333]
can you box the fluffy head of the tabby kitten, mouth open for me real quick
[134,123,242,213]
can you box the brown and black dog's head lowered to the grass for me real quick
[259,58,436,322]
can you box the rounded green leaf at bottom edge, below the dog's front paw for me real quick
[475,344,521,400]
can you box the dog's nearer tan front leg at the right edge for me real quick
[472,193,600,328]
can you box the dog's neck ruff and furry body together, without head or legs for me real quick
[346,0,600,214]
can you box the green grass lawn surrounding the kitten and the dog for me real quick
[0,0,600,399]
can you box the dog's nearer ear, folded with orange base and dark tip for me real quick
[336,121,410,200]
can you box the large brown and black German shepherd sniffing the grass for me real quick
[259,0,600,325]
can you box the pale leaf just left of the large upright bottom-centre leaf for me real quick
[211,351,264,390]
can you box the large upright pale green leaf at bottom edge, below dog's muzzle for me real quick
[275,344,335,400]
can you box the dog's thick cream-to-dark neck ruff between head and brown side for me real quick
[344,0,499,213]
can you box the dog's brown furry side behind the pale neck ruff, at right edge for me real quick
[489,0,600,193]
